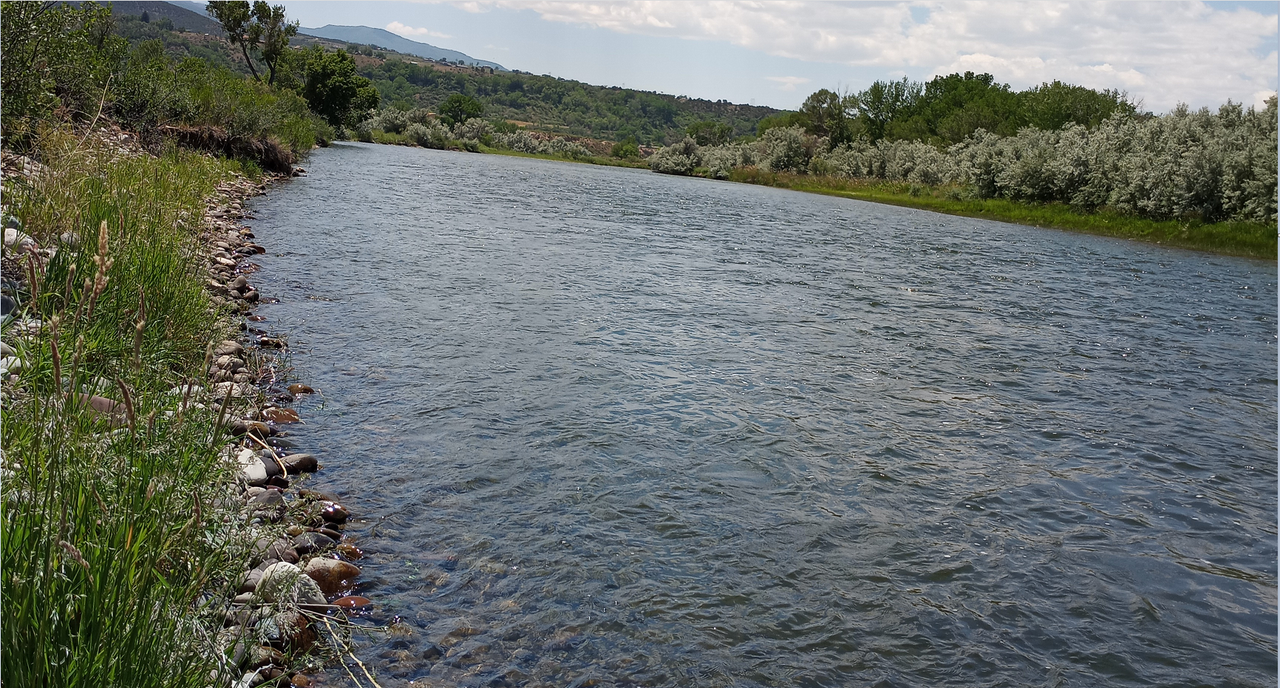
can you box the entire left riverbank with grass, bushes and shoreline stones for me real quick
[0,3,376,688]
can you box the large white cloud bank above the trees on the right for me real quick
[445,0,1277,111]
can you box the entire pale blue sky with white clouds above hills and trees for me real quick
[284,0,1280,113]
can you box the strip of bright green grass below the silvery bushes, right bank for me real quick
[730,169,1276,261]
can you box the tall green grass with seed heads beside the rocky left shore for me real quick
[0,125,247,687]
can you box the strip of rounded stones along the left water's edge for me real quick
[200,159,370,687]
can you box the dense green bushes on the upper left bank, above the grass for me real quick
[0,3,334,171]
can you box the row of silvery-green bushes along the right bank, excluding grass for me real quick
[649,97,1276,223]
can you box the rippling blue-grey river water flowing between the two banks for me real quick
[251,145,1277,688]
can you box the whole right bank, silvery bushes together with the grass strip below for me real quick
[649,78,1277,260]
